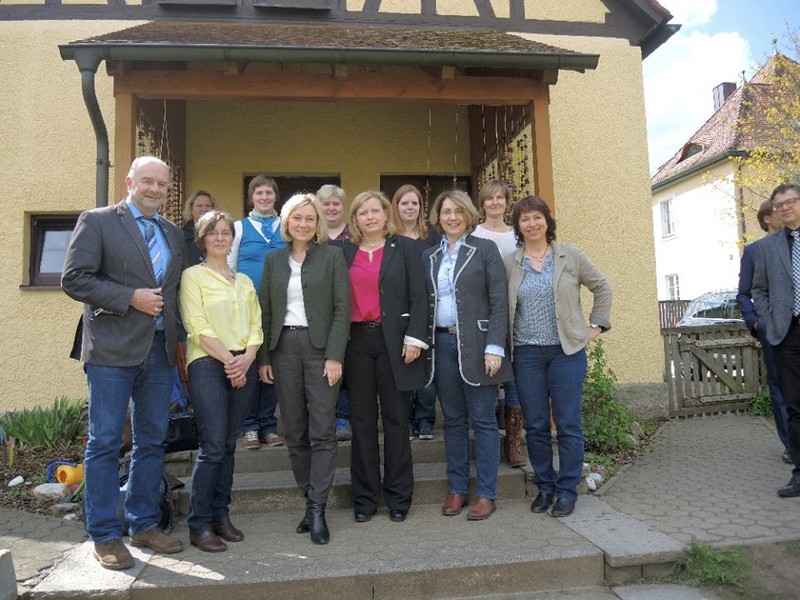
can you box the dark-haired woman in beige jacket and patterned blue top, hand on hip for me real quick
[506,196,611,517]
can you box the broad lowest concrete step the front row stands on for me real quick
[34,500,604,600]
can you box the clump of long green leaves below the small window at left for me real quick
[0,396,86,448]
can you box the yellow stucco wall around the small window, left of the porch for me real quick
[0,21,136,411]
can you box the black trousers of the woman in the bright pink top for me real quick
[344,326,414,513]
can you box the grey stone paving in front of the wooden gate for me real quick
[597,414,800,544]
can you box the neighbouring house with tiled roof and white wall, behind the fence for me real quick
[650,54,797,300]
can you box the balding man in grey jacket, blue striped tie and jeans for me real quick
[61,156,184,569]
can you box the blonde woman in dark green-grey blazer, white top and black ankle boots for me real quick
[258,194,350,544]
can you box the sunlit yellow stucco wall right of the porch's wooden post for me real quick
[520,35,663,383]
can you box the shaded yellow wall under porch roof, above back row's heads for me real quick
[186,101,469,217]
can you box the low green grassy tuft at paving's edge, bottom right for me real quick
[675,542,750,587]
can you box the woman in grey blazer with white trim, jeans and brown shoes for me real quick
[423,190,511,521]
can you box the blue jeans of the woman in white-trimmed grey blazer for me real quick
[434,332,500,500]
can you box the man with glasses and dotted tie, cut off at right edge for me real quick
[752,184,800,497]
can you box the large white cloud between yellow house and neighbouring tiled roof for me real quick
[644,29,752,172]
